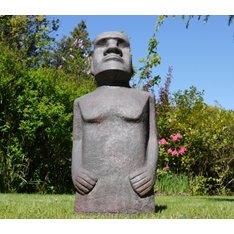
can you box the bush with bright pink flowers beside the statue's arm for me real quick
[159,133,187,172]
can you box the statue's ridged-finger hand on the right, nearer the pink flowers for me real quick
[130,167,155,197]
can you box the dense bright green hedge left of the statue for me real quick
[0,40,94,193]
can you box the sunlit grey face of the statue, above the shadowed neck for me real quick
[91,32,133,77]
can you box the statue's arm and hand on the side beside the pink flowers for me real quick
[130,94,158,197]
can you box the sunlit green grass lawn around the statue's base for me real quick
[0,194,234,219]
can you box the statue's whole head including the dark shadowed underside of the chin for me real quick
[91,32,133,85]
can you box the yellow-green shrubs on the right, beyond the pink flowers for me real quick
[158,84,234,194]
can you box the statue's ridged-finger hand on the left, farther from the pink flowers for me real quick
[73,169,97,195]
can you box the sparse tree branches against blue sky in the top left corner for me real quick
[0,15,59,68]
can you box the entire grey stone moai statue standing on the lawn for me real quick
[72,32,158,214]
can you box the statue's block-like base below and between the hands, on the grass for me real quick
[74,177,155,214]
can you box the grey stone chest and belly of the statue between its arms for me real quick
[76,86,149,176]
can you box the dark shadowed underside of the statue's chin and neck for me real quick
[95,69,132,87]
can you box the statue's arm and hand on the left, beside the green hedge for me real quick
[72,99,97,195]
